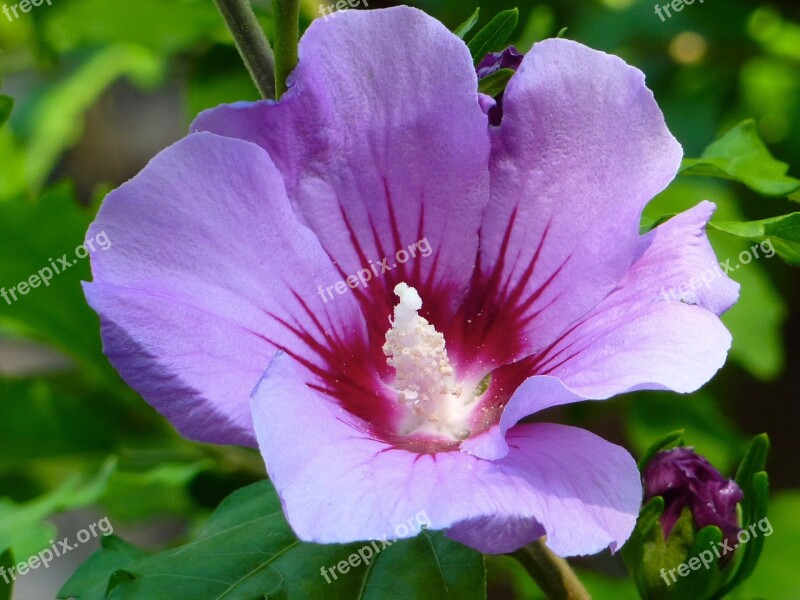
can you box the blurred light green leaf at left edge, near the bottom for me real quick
[0,458,116,559]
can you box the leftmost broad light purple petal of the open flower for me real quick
[85,133,366,444]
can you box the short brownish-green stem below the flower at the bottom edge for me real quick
[511,538,591,600]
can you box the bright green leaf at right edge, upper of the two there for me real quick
[679,119,800,199]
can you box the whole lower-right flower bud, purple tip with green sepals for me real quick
[622,432,772,600]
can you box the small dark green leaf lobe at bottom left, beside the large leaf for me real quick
[59,534,146,600]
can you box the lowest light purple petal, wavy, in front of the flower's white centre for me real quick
[253,355,642,556]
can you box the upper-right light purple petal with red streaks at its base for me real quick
[481,39,682,358]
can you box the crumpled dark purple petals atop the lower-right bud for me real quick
[642,447,744,547]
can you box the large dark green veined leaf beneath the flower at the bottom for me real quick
[59,482,486,600]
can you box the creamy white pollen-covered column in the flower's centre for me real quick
[383,283,485,441]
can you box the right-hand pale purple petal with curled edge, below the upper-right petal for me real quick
[461,202,739,459]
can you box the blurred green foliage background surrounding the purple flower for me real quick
[0,0,800,600]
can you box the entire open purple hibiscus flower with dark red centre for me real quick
[85,7,738,556]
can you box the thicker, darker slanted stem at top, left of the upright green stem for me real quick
[214,0,275,99]
